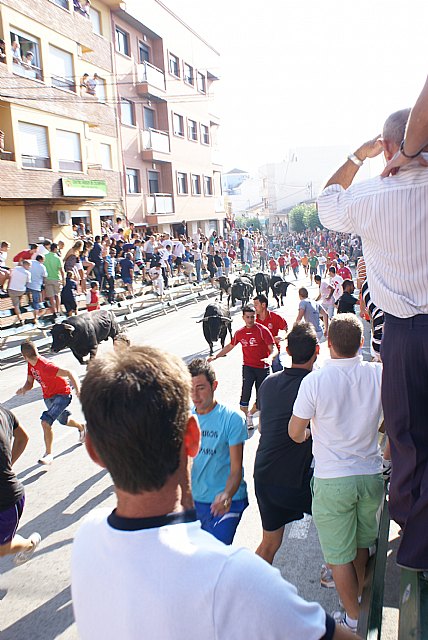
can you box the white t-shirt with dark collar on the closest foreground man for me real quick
[72,509,334,640]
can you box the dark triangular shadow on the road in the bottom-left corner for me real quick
[1,587,74,640]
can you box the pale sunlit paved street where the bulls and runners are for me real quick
[0,272,397,640]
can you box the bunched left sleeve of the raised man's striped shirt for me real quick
[318,184,357,233]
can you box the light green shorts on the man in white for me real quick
[312,473,384,564]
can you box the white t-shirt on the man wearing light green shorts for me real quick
[293,356,382,478]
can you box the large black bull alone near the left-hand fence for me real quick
[51,311,120,364]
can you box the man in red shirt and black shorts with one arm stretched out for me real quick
[207,305,277,431]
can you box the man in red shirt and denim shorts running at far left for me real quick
[16,342,86,464]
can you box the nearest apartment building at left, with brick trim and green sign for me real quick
[0,0,123,262]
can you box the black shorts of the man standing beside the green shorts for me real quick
[254,469,312,531]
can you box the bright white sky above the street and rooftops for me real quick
[163,0,428,171]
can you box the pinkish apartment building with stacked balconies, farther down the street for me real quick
[112,0,225,235]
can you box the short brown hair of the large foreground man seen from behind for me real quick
[80,347,191,495]
